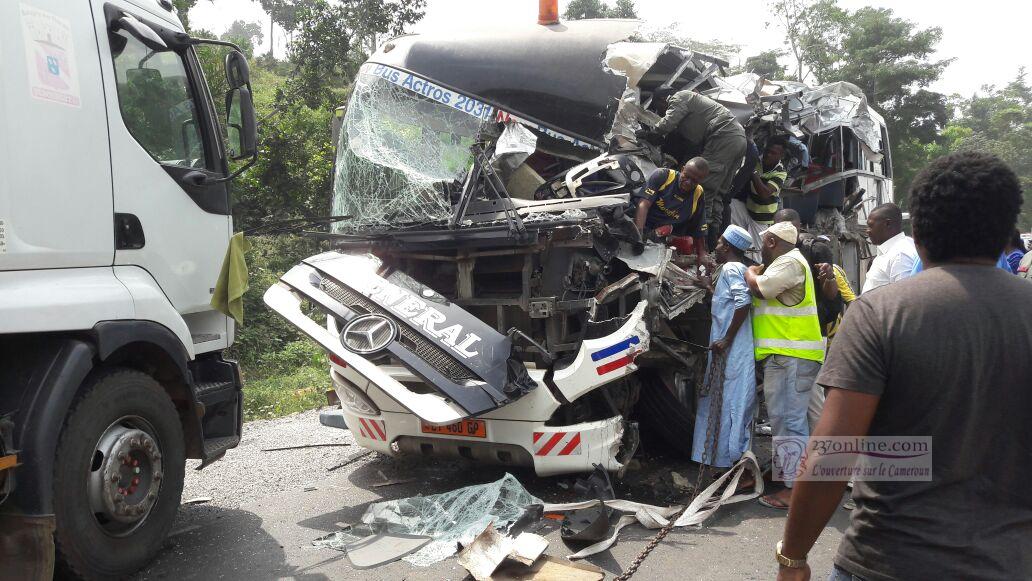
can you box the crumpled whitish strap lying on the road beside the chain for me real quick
[544,452,764,559]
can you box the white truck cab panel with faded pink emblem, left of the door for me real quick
[0,0,114,270]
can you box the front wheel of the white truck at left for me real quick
[54,368,185,579]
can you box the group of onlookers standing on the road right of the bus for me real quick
[676,153,1032,581]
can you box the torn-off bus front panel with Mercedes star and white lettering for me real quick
[265,252,537,425]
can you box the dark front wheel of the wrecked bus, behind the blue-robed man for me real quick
[636,372,696,458]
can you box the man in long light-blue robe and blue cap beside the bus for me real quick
[691,225,756,474]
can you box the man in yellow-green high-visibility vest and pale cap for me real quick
[745,222,825,509]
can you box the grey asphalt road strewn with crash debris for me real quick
[138,412,848,581]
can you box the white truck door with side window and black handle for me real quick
[93,0,232,315]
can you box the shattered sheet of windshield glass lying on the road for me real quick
[314,474,542,567]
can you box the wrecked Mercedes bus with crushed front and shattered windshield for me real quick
[265,20,891,475]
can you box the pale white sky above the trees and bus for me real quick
[190,0,1032,96]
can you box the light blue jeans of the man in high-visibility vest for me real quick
[764,355,820,488]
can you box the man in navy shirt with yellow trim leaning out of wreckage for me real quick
[635,157,709,258]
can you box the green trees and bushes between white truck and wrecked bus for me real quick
[175,0,425,408]
